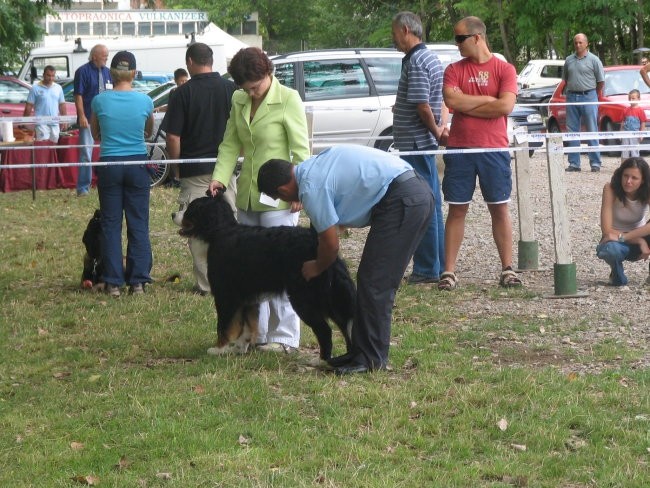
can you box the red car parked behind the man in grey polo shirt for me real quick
[546,65,650,152]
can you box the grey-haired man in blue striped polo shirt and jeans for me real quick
[392,12,448,284]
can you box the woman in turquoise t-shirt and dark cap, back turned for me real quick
[90,51,153,297]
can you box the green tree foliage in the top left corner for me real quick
[0,0,71,73]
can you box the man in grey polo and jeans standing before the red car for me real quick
[562,34,605,172]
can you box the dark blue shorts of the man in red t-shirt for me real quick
[442,147,512,205]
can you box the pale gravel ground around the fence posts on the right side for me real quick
[330,151,650,374]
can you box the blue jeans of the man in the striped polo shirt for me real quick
[402,154,445,279]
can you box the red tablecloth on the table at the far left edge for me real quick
[0,141,62,192]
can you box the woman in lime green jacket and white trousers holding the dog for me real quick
[210,47,310,352]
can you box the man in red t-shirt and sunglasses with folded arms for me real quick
[438,17,521,290]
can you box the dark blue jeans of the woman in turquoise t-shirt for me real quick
[97,154,153,286]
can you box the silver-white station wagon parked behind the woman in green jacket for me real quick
[271,49,404,153]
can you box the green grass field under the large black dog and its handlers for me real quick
[0,188,650,488]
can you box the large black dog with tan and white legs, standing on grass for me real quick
[179,195,356,360]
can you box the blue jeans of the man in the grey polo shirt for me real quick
[566,90,601,168]
